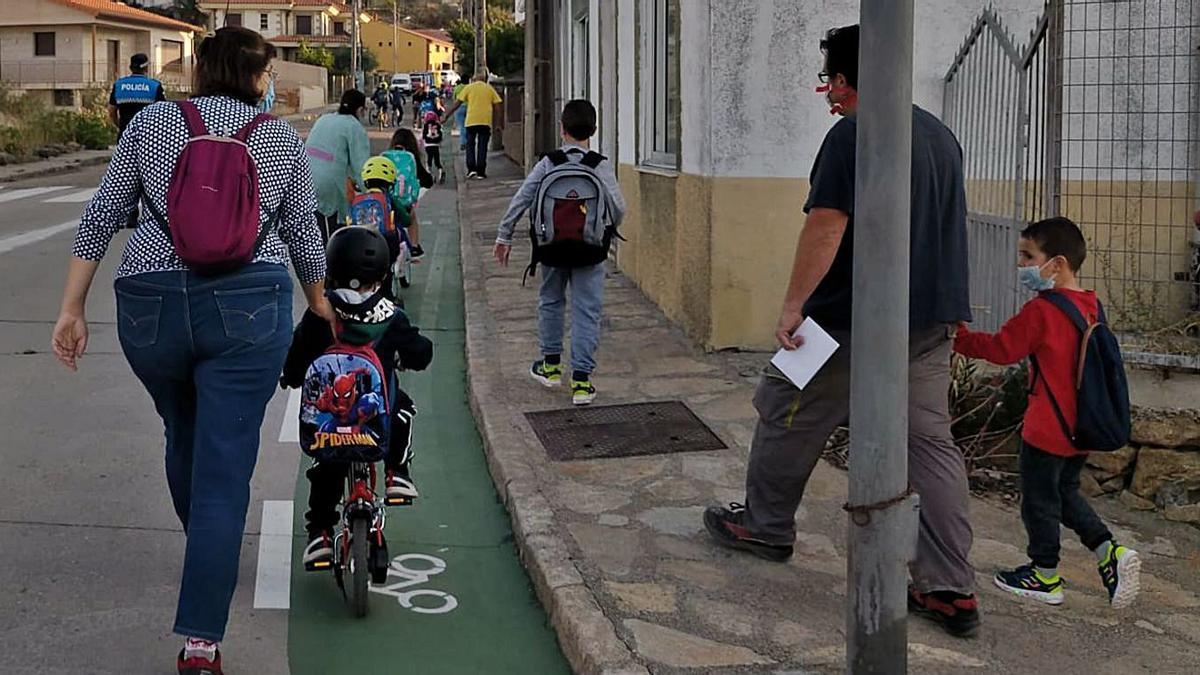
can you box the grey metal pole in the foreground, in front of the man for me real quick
[846,0,917,674]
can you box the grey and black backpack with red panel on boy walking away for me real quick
[526,150,620,274]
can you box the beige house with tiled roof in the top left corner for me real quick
[0,0,204,107]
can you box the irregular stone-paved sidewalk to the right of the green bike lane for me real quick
[458,156,1200,674]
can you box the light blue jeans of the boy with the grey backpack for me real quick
[538,263,605,374]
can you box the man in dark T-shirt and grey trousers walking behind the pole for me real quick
[704,25,979,637]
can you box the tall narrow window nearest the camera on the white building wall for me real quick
[638,0,679,169]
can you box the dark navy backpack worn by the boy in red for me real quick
[1030,291,1130,452]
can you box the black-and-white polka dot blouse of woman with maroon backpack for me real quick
[72,96,325,283]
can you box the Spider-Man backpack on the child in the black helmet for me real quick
[300,342,391,462]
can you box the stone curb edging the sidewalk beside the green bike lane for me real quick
[455,157,649,675]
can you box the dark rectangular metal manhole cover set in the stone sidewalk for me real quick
[526,401,726,460]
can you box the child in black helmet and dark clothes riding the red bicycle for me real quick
[280,227,433,569]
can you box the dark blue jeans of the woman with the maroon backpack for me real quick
[115,263,292,640]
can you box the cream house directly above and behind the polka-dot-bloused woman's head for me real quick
[198,0,352,61]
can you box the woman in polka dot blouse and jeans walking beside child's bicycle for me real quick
[52,28,332,675]
